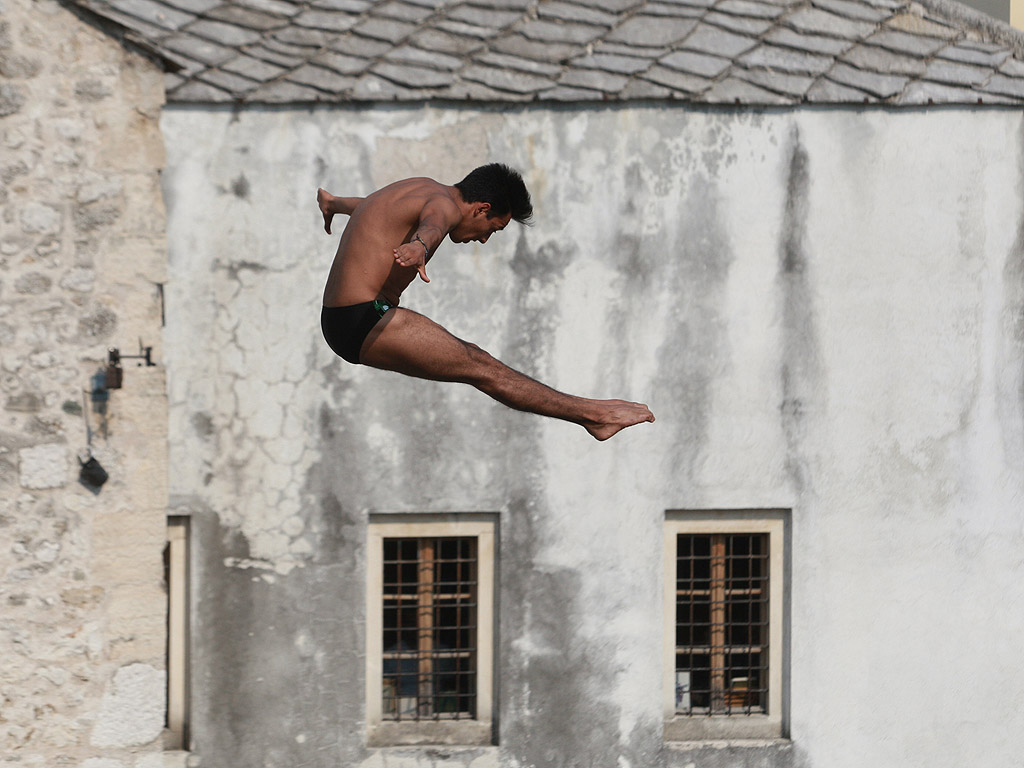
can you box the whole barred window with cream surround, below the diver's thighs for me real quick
[366,513,497,746]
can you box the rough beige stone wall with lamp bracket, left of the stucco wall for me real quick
[0,0,167,768]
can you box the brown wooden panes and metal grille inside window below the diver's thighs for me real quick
[381,537,478,721]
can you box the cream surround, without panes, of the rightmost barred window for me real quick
[663,511,786,741]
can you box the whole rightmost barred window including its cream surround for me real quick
[665,510,788,741]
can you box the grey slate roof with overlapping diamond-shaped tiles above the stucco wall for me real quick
[71,0,1024,105]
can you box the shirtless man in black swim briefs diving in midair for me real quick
[316,163,654,440]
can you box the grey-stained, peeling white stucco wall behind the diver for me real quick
[162,106,1024,768]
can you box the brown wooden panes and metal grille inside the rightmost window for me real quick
[675,534,772,716]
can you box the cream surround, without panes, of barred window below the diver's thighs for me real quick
[366,513,496,746]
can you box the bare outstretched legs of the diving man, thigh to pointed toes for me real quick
[359,308,654,440]
